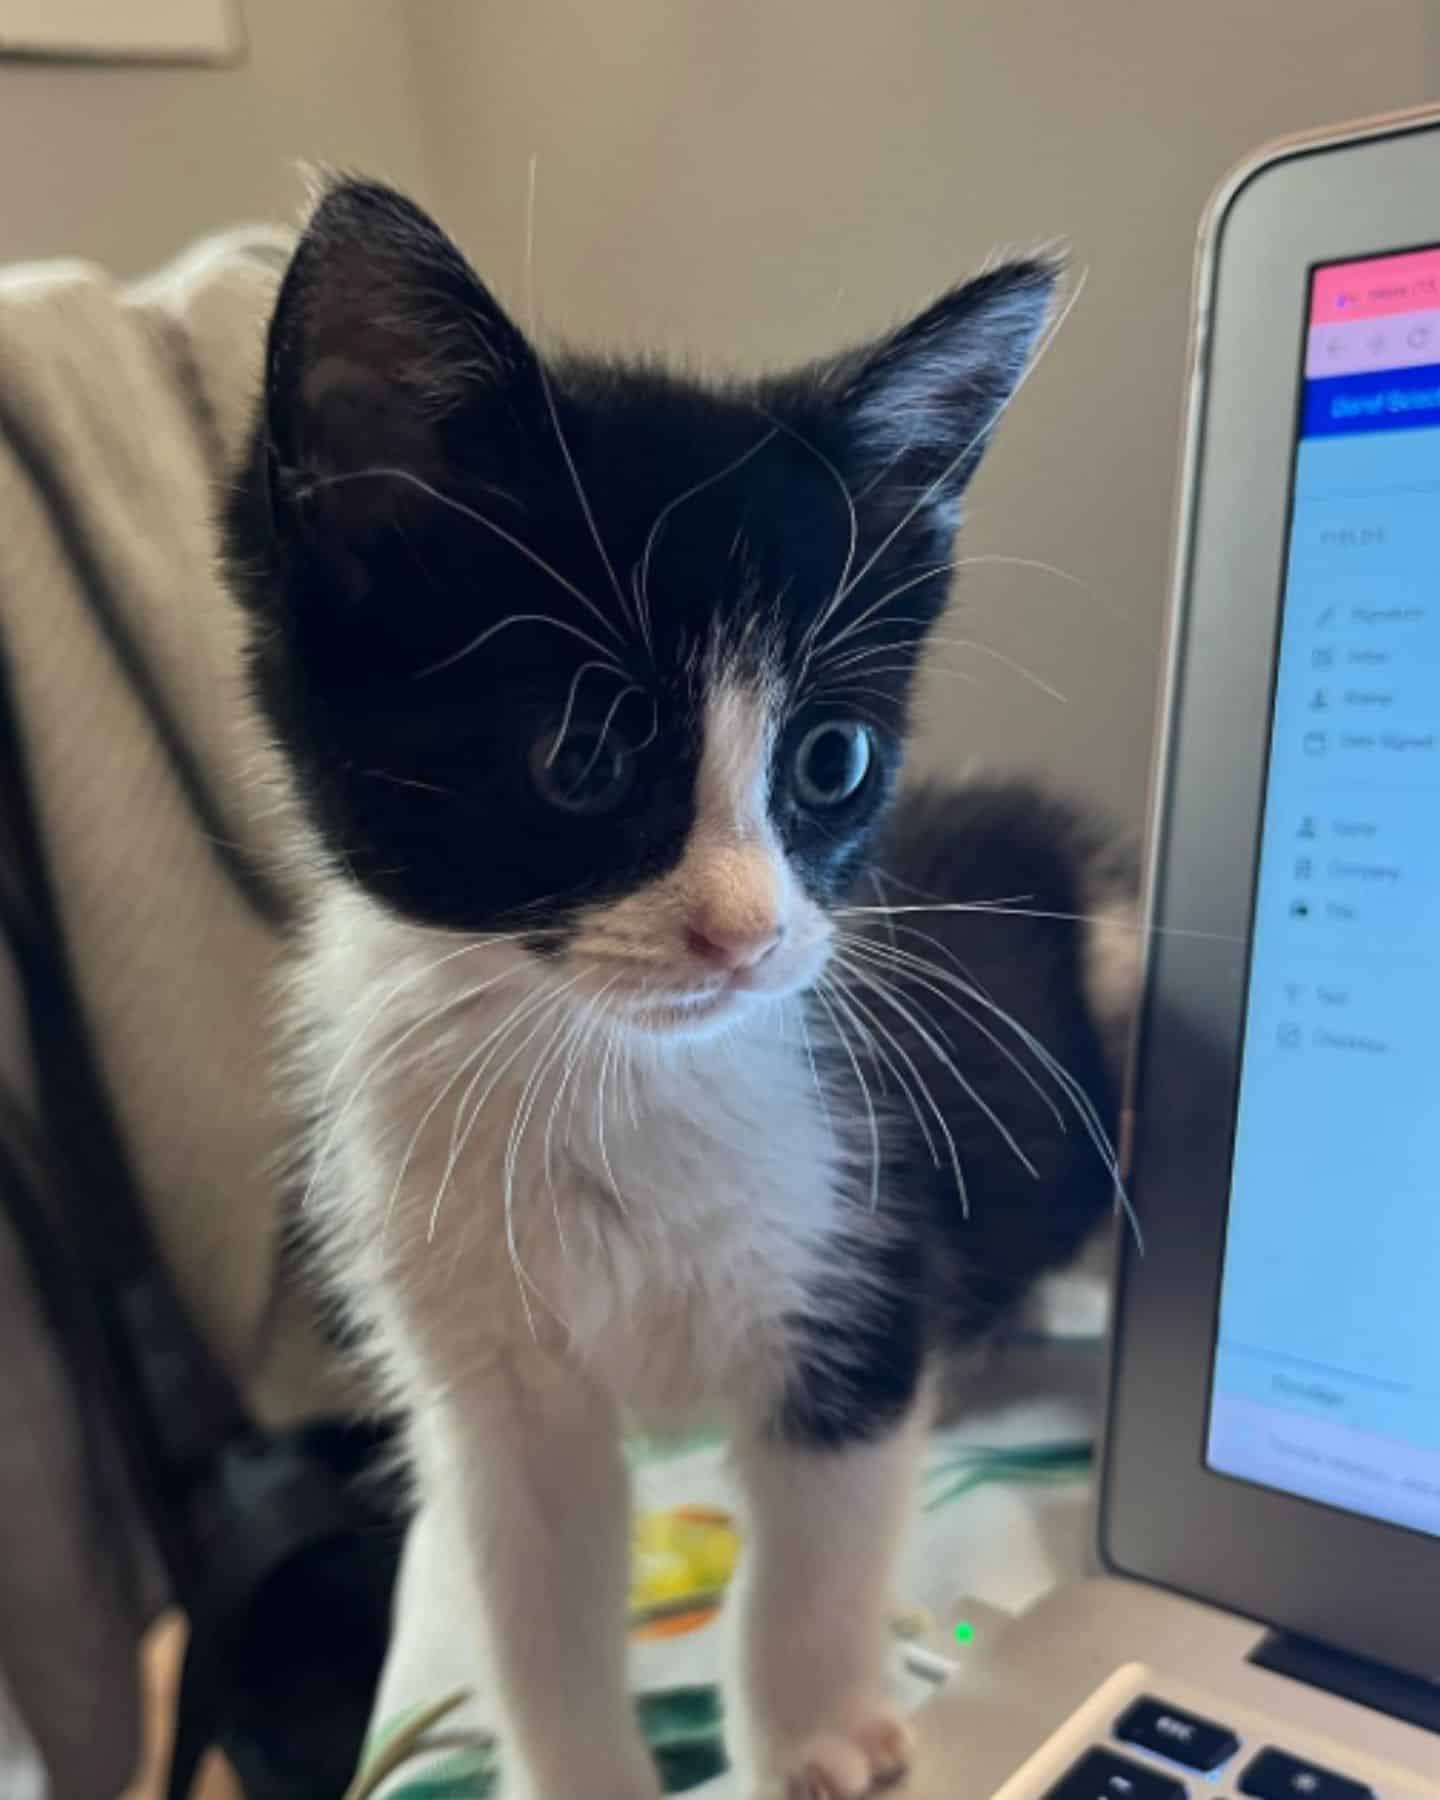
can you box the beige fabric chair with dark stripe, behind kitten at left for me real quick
[0,229,352,1800]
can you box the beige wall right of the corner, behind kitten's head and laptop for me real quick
[399,0,1438,815]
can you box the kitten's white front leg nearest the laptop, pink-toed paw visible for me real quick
[740,1409,922,1800]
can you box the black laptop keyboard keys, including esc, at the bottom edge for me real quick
[1044,1694,1377,1800]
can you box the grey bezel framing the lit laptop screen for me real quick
[1098,119,1440,1679]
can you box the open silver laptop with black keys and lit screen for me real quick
[907,113,1440,1800]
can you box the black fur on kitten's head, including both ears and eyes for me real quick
[230,182,1055,945]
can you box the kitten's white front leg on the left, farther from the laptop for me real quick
[421,1352,659,1800]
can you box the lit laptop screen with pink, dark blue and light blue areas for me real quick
[1208,248,1440,1535]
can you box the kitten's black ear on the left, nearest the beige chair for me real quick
[265,180,535,561]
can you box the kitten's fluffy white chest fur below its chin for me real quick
[302,889,849,1429]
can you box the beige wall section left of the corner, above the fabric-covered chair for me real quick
[0,0,433,270]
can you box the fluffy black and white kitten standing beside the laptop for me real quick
[230,182,1129,1800]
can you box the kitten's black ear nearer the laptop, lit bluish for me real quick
[832,257,1062,526]
